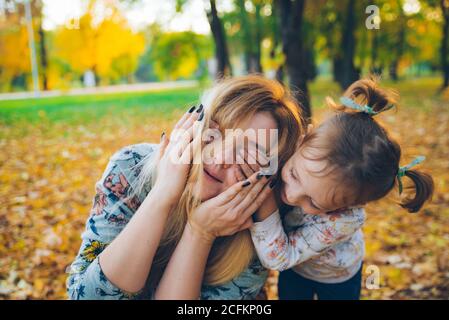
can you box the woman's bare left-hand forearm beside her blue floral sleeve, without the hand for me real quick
[99,189,171,293]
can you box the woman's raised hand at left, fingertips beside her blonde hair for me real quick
[153,105,204,206]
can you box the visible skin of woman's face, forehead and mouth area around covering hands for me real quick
[200,112,278,201]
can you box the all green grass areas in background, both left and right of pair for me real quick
[0,78,440,126]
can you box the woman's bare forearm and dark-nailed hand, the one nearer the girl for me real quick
[155,174,271,299]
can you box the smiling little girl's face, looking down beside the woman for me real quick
[281,149,345,214]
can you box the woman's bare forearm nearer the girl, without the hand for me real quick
[155,224,213,300]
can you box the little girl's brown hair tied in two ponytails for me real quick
[301,79,434,212]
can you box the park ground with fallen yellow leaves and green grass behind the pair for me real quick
[0,79,449,299]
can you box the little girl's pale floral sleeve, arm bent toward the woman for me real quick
[250,208,365,271]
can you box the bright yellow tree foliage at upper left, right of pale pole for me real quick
[55,0,145,82]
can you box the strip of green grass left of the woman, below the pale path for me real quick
[0,88,200,125]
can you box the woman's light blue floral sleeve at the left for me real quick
[66,148,154,300]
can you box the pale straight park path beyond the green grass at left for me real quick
[0,80,198,101]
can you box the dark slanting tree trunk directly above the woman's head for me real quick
[207,0,232,78]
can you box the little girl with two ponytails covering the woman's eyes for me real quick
[251,80,433,299]
